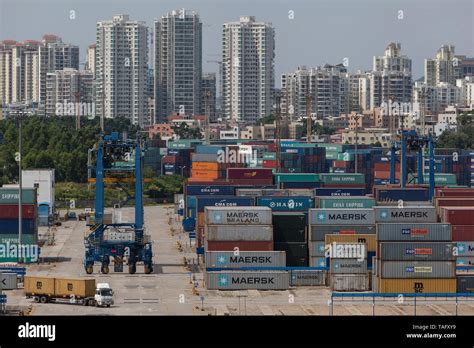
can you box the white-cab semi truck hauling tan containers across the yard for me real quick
[24,276,114,307]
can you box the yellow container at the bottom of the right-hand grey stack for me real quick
[378,278,456,294]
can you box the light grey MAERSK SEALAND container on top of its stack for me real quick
[204,207,272,225]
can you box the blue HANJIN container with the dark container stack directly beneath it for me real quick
[257,196,314,267]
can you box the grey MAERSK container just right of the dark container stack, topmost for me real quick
[309,209,375,225]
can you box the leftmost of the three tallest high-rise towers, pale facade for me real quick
[95,15,150,126]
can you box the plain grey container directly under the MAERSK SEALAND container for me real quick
[205,225,273,241]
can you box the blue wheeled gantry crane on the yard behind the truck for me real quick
[84,132,153,274]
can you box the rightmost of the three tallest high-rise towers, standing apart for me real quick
[221,16,275,123]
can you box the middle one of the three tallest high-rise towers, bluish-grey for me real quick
[154,9,202,123]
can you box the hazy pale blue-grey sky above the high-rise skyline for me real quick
[0,0,474,86]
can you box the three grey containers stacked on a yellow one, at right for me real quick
[373,220,456,294]
